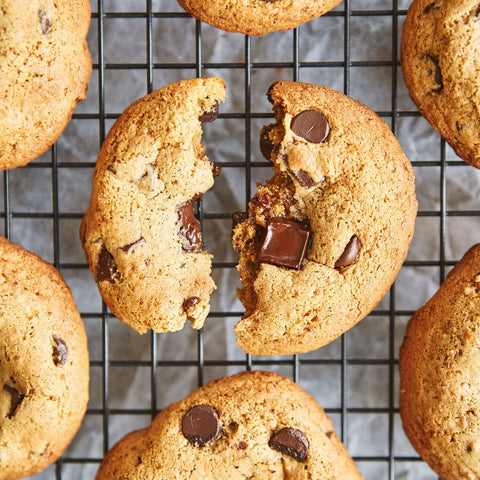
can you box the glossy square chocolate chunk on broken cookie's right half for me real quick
[258,217,310,270]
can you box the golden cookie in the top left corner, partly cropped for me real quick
[0,0,92,170]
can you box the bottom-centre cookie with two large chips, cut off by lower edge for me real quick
[96,371,363,480]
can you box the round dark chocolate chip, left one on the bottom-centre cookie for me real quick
[182,405,220,447]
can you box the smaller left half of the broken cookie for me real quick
[80,77,225,333]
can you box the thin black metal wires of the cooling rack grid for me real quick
[6,0,480,480]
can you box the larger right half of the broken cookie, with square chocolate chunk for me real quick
[232,82,417,355]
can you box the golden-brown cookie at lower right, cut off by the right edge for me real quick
[400,245,480,480]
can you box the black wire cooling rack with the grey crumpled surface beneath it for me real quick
[9,0,480,480]
